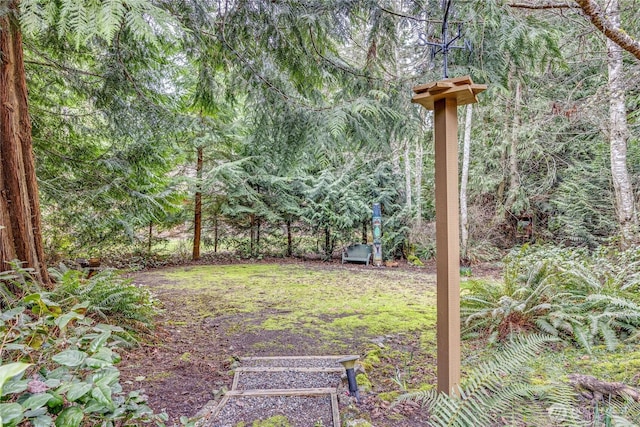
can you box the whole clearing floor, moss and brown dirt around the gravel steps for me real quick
[120,260,500,427]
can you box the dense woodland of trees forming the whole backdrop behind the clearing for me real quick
[0,0,640,281]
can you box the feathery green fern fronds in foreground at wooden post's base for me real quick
[397,334,586,427]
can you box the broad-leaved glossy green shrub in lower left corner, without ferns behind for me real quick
[0,273,191,427]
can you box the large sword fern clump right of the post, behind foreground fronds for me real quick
[462,245,640,351]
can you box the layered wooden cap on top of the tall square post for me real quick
[411,76,487,110]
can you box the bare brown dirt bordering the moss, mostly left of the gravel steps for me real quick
[120,259,500,427]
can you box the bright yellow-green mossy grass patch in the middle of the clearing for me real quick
[154,264,436,344]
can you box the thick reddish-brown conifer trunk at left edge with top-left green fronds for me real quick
[0,0,168,286]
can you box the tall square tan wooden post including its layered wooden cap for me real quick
[412,76,487,394]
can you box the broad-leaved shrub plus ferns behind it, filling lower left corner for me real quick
[0,267,189,427]
